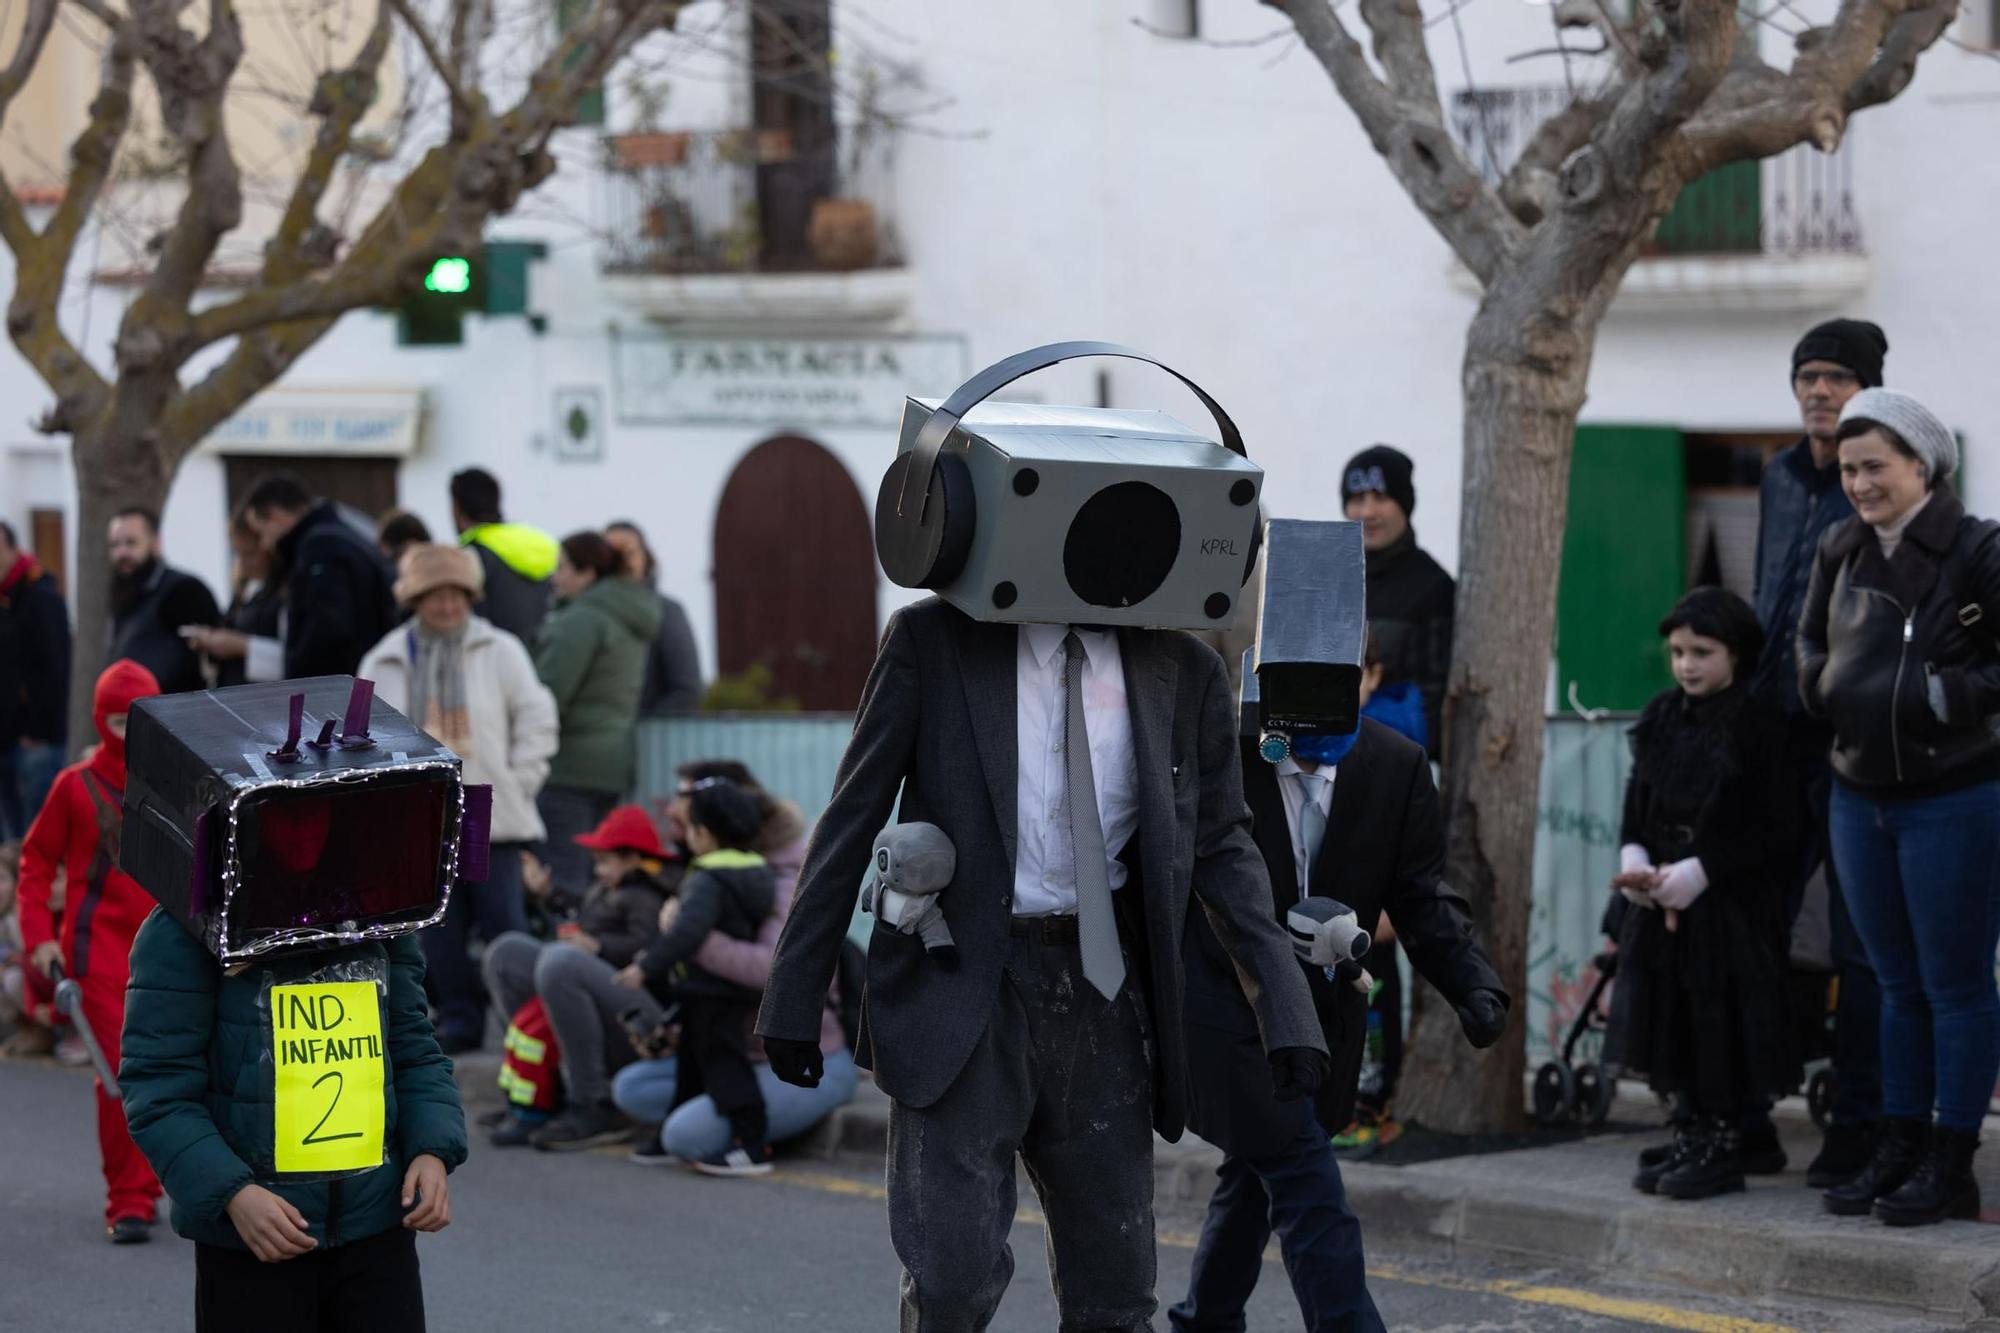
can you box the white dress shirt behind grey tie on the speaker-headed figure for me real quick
[1014,624,1138,917]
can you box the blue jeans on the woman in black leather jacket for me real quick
[1832,783,2000,1131]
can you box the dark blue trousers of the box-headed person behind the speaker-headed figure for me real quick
[1166,1123,1384,1333]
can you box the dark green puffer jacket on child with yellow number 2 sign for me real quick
[118,909,466,1249]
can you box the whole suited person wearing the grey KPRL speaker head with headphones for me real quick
[758,342,1328,1333]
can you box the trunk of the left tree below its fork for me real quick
[70,412,170,757]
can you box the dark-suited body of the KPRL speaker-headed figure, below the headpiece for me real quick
[758,598,1326,1333]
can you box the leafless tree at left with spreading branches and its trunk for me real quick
[0,0,684,733]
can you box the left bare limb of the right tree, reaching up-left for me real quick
[1266,0,1526,282]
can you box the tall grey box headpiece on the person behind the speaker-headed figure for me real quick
[1242,518,1368,765]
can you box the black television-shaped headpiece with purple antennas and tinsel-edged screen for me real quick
[122,677,492,965]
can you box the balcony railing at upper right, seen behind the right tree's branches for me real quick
[1452,86,1862,256]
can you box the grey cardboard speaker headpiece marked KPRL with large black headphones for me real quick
[876,342,1264,628]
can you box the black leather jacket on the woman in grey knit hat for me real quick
[1798,492,2000,795]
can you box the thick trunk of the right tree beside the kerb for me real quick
[1398,278,1596,1133]
